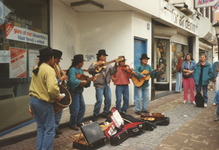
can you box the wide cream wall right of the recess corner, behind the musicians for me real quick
[77,11,133,104]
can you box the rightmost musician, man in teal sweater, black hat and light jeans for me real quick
[134,54,161,115]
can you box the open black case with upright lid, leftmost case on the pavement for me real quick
[73,122,106,150]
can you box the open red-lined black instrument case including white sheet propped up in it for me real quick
[104,108,154,146]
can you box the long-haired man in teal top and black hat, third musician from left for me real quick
[66,54,95,131]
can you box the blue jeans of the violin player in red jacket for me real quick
[116,85,129,112]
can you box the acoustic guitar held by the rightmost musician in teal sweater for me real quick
[132,64,167,87]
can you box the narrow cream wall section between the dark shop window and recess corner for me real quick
[50,0,79,70]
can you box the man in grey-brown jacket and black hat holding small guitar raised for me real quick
[88,49,118,121]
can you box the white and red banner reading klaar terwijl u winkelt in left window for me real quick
[6,24,48,46]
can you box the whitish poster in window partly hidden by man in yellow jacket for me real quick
[28,50,39,77]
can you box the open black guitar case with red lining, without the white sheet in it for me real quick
[104,108,154,146]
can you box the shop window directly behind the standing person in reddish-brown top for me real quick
[171,42,188,82]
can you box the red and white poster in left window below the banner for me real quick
[9,47,27,78]
